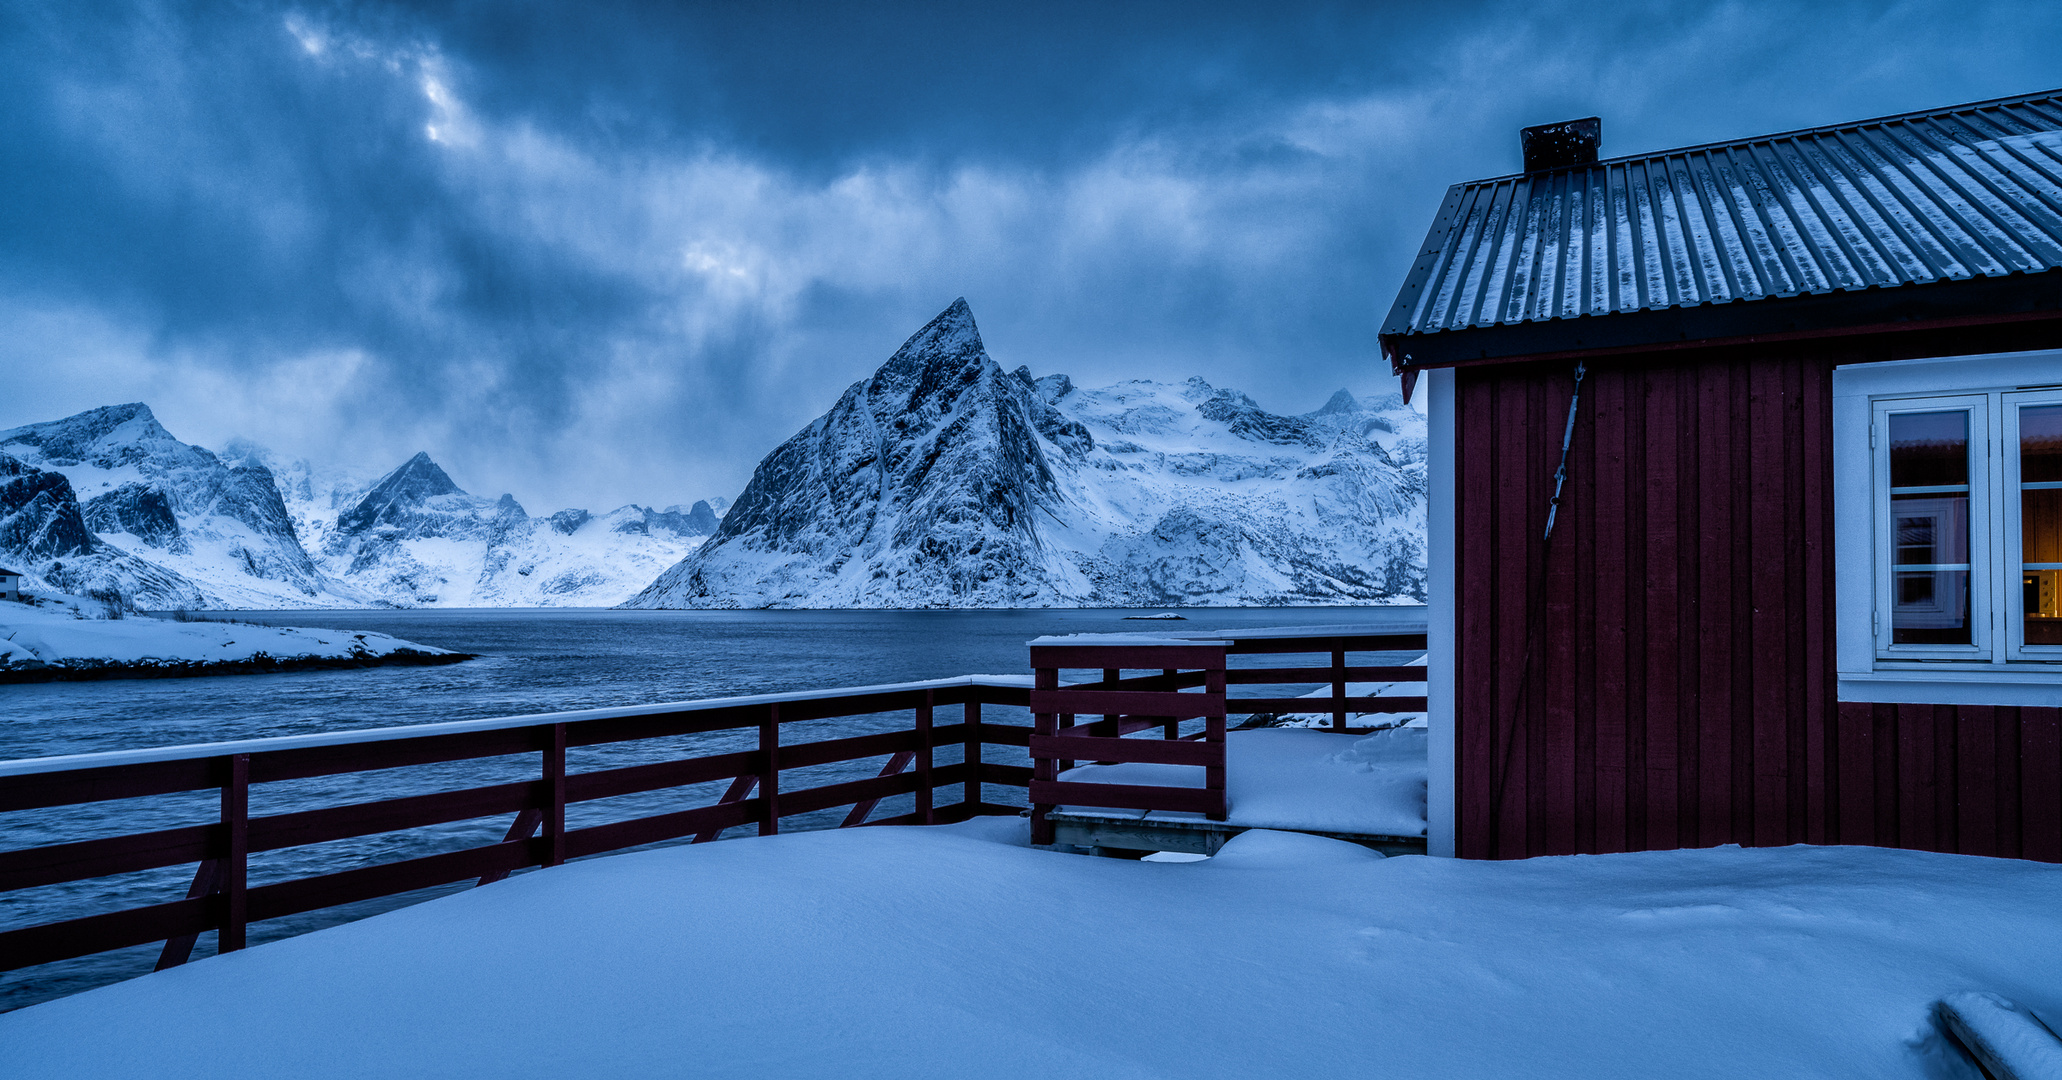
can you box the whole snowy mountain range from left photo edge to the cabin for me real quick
[0,301,1425,608]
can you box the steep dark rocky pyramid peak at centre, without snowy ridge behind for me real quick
[639,301,1093,606]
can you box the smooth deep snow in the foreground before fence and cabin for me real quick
[0,818,2062,1080]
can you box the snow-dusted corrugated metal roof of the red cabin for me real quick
[1382,91,2062,352]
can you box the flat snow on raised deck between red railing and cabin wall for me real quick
[1060,728,1425,837]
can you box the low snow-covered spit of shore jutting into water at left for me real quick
[0,596,470,682]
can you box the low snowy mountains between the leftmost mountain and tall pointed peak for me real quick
[307,453,718,608]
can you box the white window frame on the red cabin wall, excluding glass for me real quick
[1833,350,2062,705]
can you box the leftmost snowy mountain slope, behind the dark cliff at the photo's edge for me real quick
[0,404,326,606]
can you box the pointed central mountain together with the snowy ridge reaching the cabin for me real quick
[629,301,1425,608]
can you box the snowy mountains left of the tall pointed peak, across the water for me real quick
[0,404,724,608]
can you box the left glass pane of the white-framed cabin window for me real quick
[1889,408,1975,645]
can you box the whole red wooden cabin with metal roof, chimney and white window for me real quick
[1382,91,2062,862]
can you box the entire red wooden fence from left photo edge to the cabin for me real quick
[0,633,1425,985]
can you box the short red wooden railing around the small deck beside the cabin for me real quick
[1029,631,1427,843]
